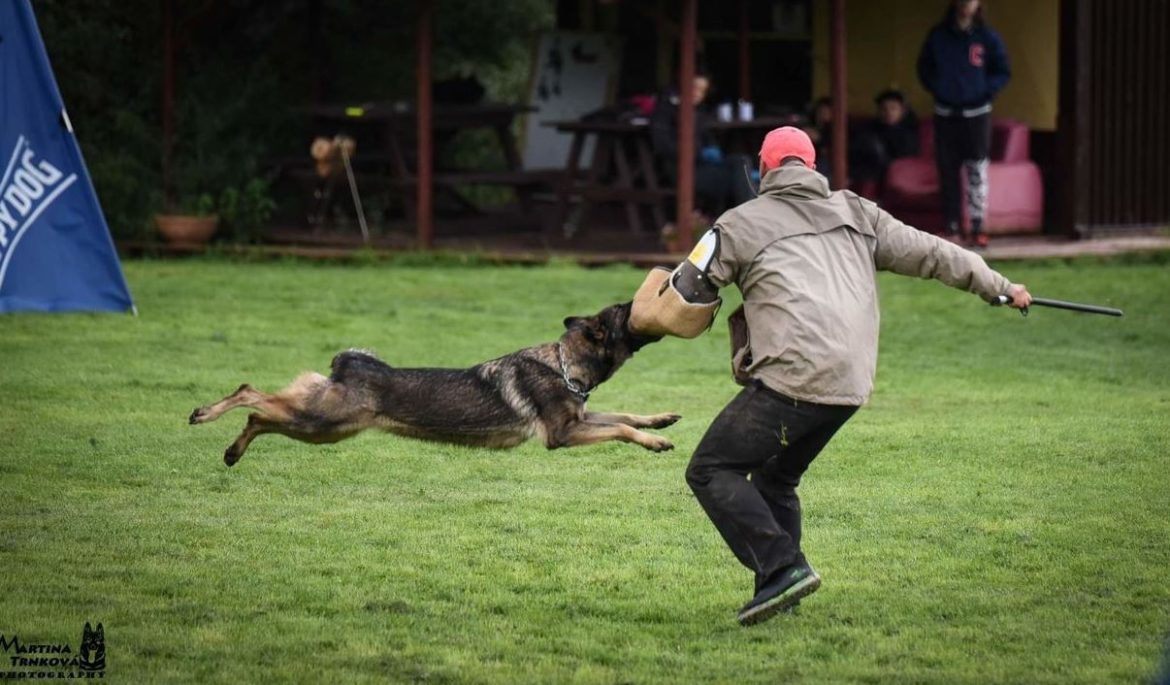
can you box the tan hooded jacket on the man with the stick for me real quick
[709,164,1011,405]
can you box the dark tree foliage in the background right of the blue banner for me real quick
[34,0,553,238]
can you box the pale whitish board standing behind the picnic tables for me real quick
[524,32,621,169]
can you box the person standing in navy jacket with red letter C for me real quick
[918,0,1012,247]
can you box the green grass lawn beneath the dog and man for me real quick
[0,254,1170,684]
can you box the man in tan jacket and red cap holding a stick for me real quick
[631,126,1031,625]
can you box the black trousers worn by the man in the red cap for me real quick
[687,383,858,590]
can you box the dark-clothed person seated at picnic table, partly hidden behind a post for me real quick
[651,74,755,217]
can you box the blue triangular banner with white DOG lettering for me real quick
[0,0,133,313]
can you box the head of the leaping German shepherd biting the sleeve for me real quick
[560,302,662,385]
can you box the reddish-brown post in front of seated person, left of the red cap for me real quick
[674,0,697,251]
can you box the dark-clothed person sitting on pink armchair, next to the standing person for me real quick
[849,89,918,188]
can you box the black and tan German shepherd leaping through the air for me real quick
[190,302,680,466]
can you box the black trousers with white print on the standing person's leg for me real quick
[935,112,991,232]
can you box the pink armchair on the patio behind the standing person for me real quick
[880,117,1044,235]
